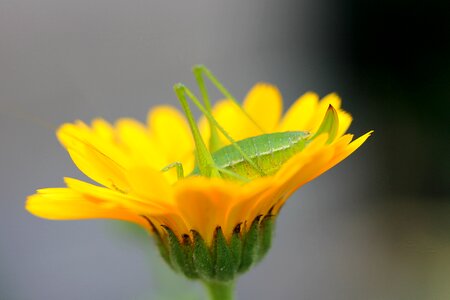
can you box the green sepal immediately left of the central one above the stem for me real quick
[191,230,214,279]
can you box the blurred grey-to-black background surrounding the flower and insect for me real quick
[0,0,450,300]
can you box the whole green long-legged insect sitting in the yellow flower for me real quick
[162,66,338,181]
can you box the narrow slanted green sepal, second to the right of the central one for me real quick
[238,216,262,273]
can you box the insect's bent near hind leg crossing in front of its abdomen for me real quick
[175,84,266,176]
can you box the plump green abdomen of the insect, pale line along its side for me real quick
[212,131,309,179]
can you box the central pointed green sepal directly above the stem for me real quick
[213,227,236,281]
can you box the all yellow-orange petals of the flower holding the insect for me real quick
[26,84,371,284]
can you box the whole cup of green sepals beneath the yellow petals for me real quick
[153,212,275,282]
